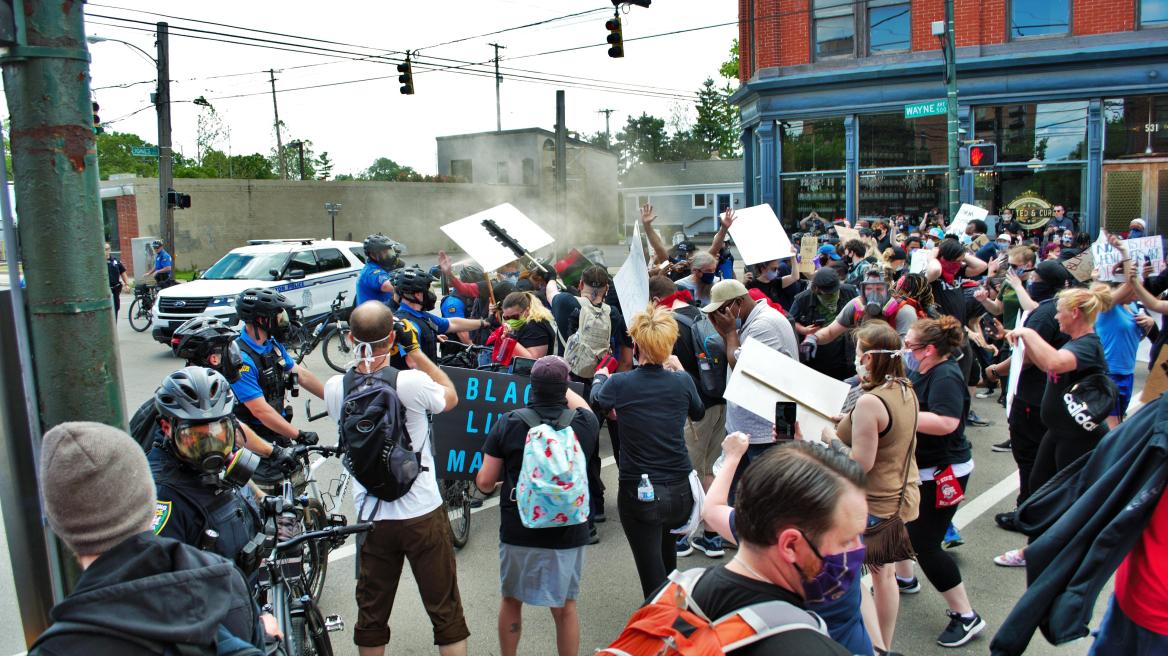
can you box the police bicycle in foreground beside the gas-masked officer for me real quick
[253,480,374,656]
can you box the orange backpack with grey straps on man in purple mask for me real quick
[597,568,828,656]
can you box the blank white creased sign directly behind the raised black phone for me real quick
[723,337,850,440]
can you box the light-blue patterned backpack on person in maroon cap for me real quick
[514,407,590,529]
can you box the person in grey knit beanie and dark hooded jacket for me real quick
[29,421,277,656]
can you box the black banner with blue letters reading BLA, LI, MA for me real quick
[433,367,584,481]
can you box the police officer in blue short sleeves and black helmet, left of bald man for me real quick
[231,287,325,488]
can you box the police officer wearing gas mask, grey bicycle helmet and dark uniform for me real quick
[146,367,263,575]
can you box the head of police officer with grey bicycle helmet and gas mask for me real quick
[154,367,259,487]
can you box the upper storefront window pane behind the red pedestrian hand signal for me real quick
[973,100,1087,163]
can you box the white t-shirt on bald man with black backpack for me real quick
[325,370,446,521]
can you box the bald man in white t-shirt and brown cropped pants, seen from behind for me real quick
[325,301,471,656]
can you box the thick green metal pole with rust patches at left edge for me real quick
[0,2,126,602]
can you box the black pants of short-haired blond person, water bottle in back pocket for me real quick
[617,479,694,598]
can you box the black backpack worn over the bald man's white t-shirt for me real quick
[338,367,425,499]
